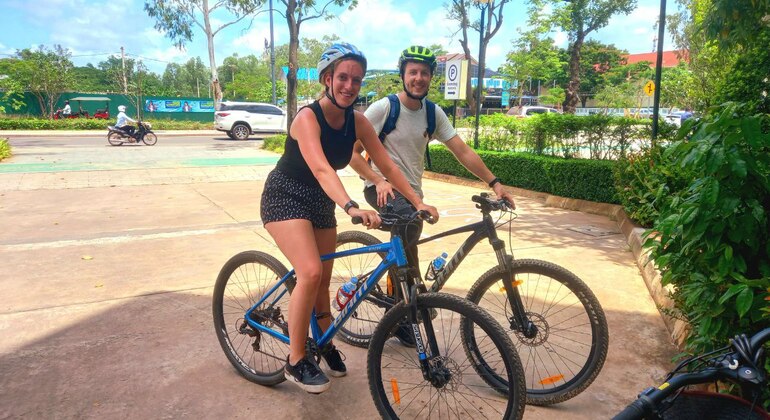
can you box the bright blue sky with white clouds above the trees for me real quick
[0,0,674,74]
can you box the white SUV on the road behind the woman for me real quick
[214,102,286,140]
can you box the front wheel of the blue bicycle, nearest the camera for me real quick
[367,293,526,419]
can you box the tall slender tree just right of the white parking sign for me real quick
[446,0,509,114]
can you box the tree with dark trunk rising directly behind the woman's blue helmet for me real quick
[281,0,358,131]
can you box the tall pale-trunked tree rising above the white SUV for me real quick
[144,0,264,107]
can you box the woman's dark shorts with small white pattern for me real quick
[259,169,337,229]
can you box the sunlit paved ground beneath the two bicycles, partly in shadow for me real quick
[0,133,675,419]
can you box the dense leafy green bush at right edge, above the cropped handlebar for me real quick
[645,103,770,352]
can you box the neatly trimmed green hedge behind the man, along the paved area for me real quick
[430,145,618,204]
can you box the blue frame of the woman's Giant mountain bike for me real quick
[245,236,406,348]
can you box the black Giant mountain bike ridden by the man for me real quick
[331,194,609,405]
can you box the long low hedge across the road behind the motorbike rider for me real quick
[0,116,214,130]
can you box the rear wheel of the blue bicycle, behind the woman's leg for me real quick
[212,251,296,385]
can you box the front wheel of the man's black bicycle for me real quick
[467,260,609,405]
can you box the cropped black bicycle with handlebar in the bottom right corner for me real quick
[614,328,770,420]
